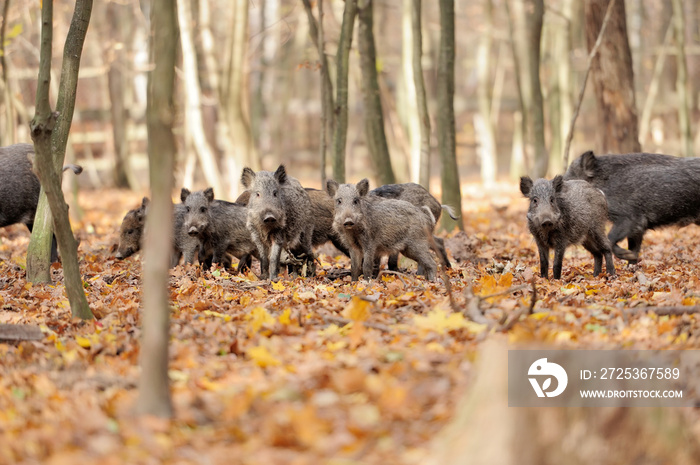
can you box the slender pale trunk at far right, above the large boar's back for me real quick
[671,0,693,157]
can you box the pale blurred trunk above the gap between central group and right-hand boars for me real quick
[474,0,496,187]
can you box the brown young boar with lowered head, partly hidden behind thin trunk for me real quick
[115,197,201,268]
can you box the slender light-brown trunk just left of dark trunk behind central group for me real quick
[411,0,430,189]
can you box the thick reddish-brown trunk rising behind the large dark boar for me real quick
[584,0,641,153]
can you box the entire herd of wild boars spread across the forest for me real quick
[0,144,700,279]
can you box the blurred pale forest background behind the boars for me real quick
[0,0,700,198]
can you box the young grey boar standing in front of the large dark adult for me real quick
[520,176,615,279]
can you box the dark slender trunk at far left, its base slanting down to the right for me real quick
[30,0,94,319]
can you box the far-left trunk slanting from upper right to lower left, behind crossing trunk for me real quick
[27,0,92,294]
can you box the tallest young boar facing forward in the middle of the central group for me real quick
[241,165,315,280]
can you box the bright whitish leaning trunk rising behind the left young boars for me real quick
[177,0,225,195]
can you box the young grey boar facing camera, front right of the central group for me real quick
[326,179,437,280]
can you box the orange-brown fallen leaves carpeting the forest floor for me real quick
[0,190,700,464]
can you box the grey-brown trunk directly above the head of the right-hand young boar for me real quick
[507,0,549,177]
